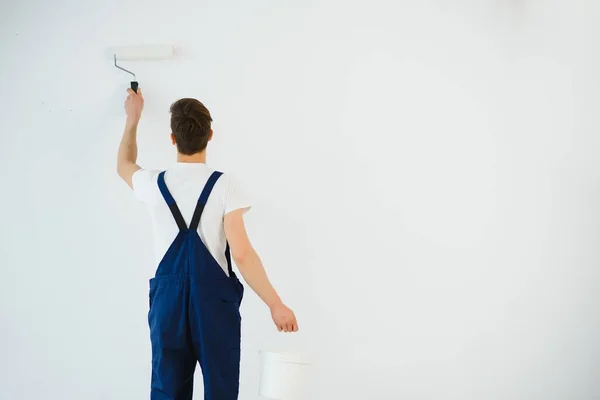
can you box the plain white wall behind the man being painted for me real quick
[0,0,600,400]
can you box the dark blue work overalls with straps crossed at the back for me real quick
[148,171,244,400]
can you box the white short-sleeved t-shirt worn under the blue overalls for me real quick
[133,163,251,276]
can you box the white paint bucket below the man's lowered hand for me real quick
[259,350,312,400]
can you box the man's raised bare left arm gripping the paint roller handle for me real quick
[117,89,144,188]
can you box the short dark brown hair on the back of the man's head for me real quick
[171,99,212,156]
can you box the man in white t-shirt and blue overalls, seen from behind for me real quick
[117,89,298,400]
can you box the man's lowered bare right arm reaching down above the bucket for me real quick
[224,209,298,332]
